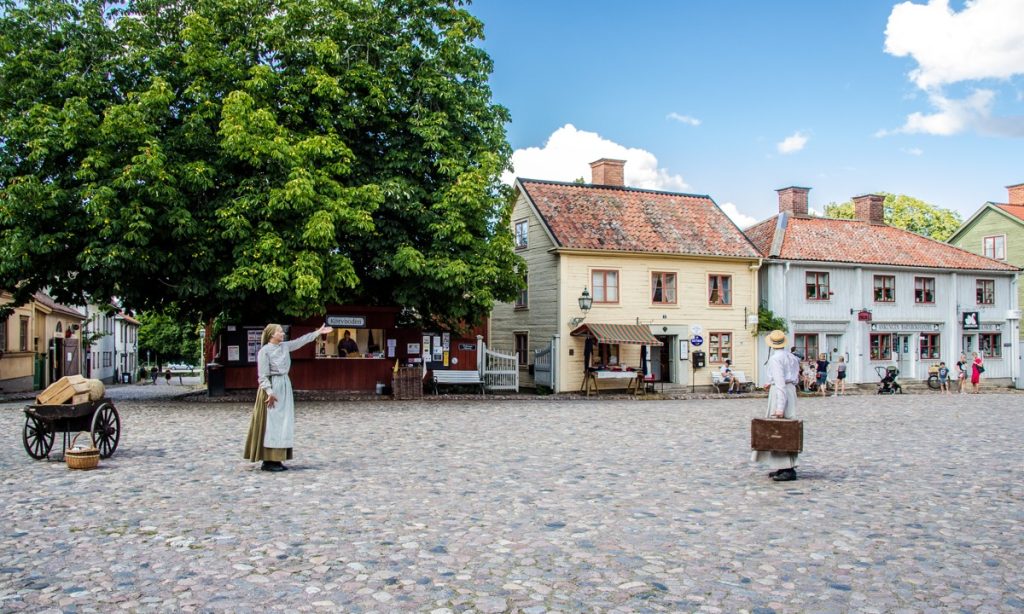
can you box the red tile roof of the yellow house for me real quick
[518,179,759,258]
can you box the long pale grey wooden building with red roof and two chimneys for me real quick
[746,187,1020,384]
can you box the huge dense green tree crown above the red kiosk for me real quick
[0,0,519,321]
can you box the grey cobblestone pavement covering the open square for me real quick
[0,394,1024,614]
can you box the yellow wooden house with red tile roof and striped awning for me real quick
[489,160,761,392]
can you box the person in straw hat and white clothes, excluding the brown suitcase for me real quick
[751,331,800,482]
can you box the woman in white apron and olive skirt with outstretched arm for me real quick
[245,324,333,471]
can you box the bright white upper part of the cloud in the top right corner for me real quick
[886,0,1024,89]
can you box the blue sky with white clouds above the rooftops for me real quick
[469,0,1024,225]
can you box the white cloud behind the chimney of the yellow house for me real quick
[502,124,689,191]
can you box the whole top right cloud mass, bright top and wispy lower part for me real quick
[876,0,1024,136]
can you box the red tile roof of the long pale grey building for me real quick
[746,215,1019,271]
